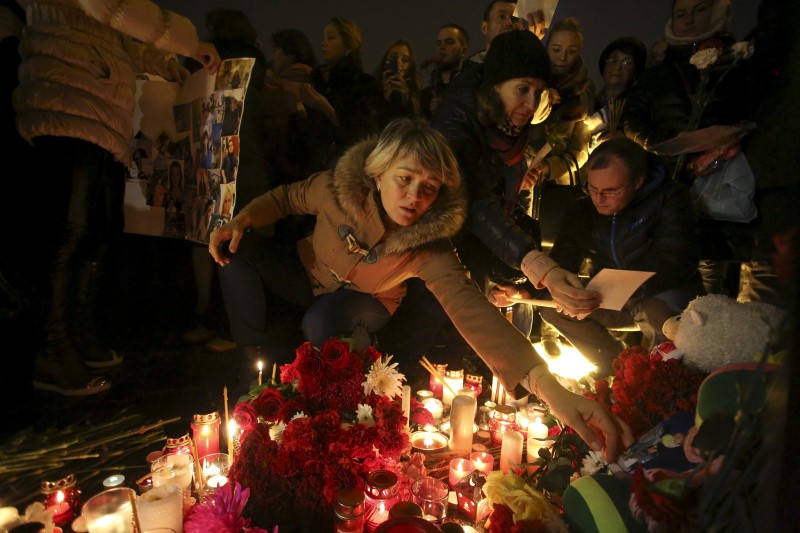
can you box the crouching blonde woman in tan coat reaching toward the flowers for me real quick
[209,118,632,458]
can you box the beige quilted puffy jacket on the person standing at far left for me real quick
[12,0,198,164]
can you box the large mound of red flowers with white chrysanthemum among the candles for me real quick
[225,339,410,531]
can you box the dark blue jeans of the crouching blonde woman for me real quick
[219,232,391,349]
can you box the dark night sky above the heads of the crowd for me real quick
[157,0,760,85]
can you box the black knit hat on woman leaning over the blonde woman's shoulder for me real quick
[483,30,550,85]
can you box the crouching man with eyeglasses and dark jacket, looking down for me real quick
[540,137,703,376]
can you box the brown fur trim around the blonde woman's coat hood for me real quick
[330,140,467,254]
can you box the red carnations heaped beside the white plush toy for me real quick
[584,346,705,438]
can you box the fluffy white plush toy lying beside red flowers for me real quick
[662,294,783,373]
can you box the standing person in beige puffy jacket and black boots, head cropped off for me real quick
[12,0,219,396]
